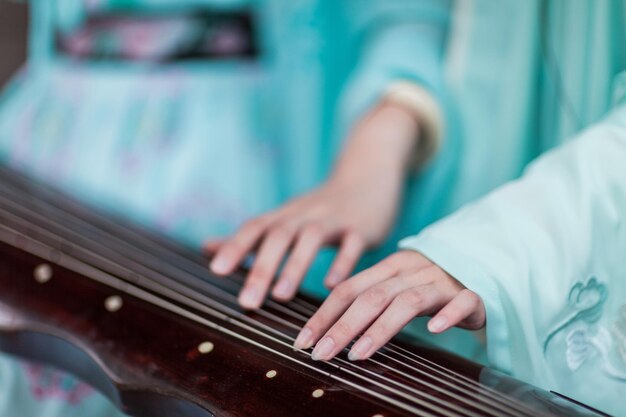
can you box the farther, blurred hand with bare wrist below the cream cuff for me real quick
[205,101,418,309]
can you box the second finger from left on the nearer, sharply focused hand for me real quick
[311,278,411,360]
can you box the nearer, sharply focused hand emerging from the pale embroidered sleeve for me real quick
[294,251,485,360]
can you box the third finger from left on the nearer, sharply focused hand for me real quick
[348,284,441,361]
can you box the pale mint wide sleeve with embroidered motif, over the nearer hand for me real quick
[400,104,626,410]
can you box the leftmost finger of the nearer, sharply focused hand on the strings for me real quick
[294,261,396,349]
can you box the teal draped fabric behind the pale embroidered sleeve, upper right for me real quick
[405,0,626,361]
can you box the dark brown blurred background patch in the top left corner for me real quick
[0,0,28,88]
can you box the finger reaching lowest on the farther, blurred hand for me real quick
[239,226,295,309]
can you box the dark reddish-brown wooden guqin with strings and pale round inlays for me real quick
[0,168,602,417]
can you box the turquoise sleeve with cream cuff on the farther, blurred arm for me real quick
[338,0,451,166]
